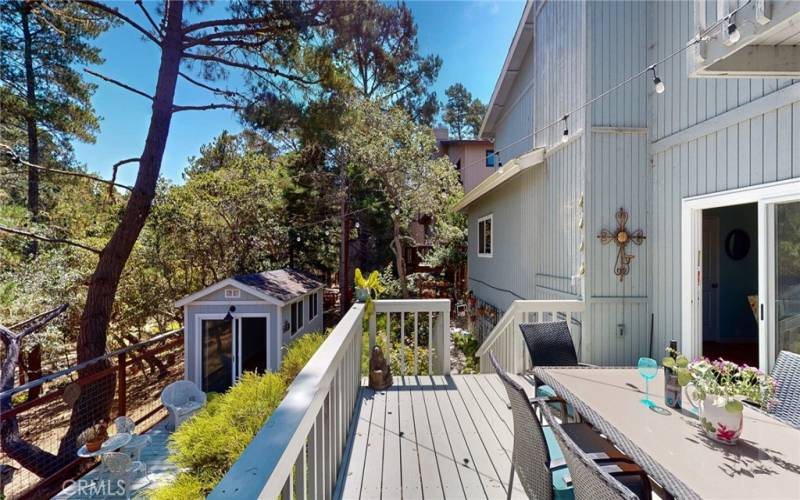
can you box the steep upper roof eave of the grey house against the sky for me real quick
[478,0,535,138]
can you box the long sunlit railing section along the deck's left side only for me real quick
[208,304,364,499]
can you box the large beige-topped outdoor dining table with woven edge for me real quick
[533,367,800,499]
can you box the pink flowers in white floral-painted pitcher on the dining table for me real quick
[663,355,775,444]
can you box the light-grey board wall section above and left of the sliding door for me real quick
[647,1,800,360]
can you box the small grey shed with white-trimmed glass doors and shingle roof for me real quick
[175,269,323,392]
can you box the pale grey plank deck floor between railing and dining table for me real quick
[339,375,525,500]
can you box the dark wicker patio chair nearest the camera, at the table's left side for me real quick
[541,405,652,500]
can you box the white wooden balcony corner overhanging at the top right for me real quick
[687,0,800,78]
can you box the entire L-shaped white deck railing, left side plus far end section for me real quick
[209,300,450,500]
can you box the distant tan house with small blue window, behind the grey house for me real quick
[434,128,498,193]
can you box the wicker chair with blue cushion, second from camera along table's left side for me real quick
[489,353,644,499]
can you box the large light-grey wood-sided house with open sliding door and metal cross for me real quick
[458,0,800,368]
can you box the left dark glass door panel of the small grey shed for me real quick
[200,319,234,392]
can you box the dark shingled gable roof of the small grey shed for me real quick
[175,269,324,307]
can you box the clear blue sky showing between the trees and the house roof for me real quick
[75,0,524,183]
